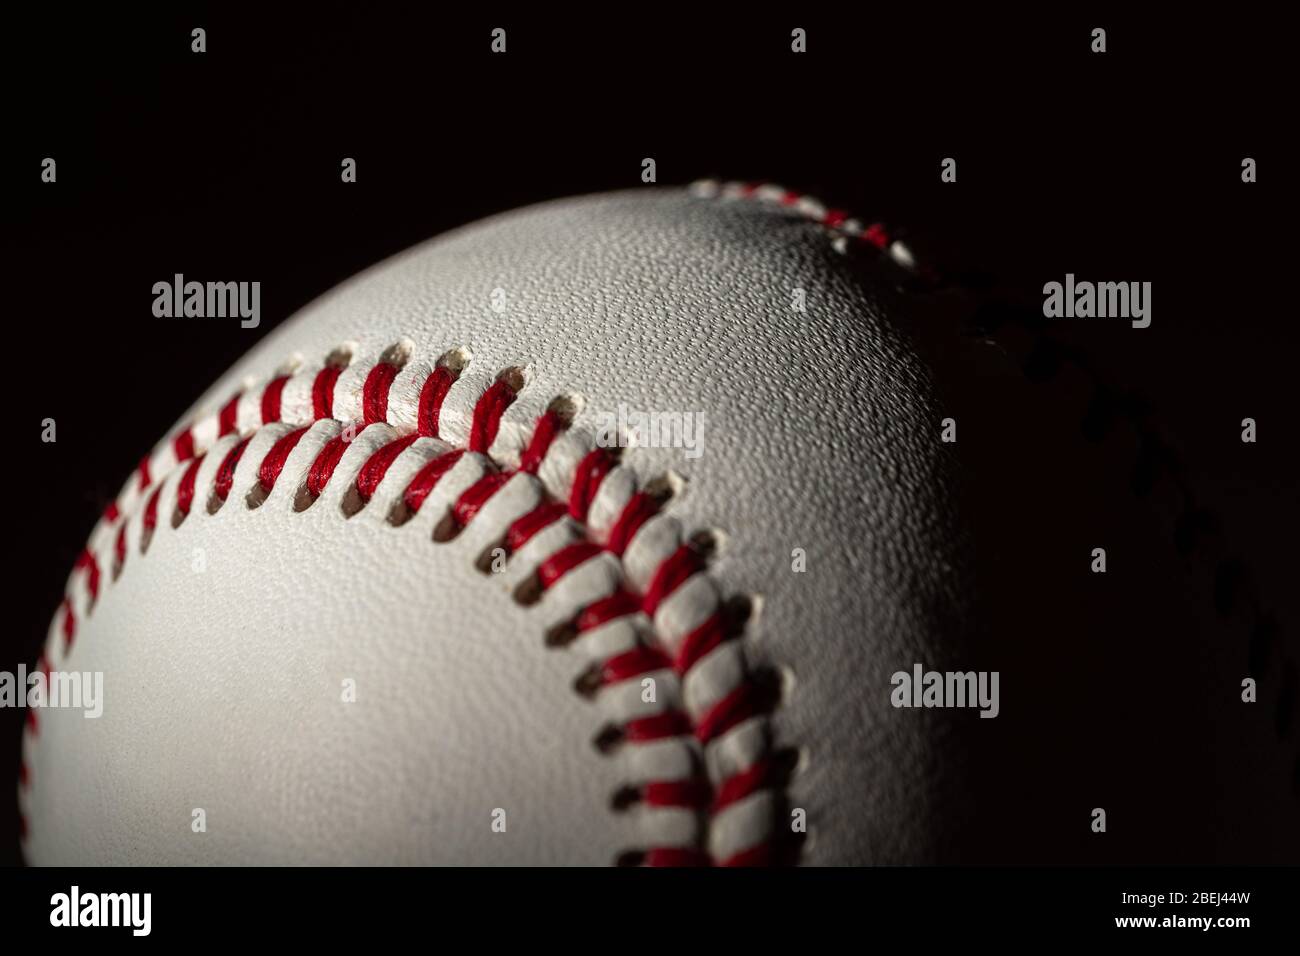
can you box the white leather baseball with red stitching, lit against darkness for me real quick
[20,185,966,864]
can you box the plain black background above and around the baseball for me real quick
[0,5,1297,861]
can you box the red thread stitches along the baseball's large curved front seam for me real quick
[32,348,780,866]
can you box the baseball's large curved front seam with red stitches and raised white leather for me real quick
[20,341,781,865]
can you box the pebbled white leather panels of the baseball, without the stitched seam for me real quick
[23,189,967,864]
